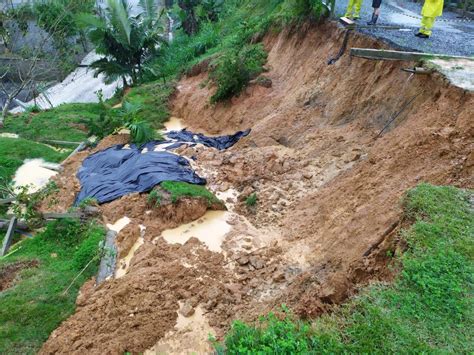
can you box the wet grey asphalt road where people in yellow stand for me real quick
[336,0,474,56]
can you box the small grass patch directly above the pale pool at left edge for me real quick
[0,137,67,183]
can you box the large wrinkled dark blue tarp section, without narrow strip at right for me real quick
[76,146,206,204]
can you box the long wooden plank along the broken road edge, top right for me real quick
[351,48,474,61]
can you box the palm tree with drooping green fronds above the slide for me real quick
[79,0,163,87]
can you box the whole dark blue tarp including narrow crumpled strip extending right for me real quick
[76,130,250,204]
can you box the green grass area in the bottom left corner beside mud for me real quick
[0,221,104,354]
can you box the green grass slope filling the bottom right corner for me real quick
[216,184,474,354]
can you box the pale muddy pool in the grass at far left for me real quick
[13,159,57,192]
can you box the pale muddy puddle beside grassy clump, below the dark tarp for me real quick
[162,211,231,253]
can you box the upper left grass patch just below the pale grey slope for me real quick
[0,104,101,142]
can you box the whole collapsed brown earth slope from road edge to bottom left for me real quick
[42,21,474,353]
